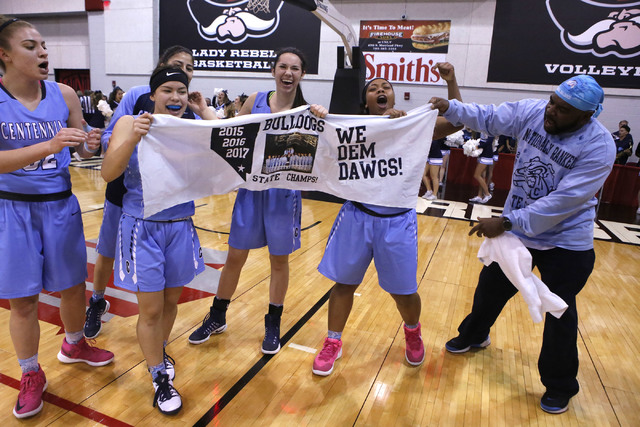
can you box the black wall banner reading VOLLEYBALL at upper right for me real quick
[487,0,640,89]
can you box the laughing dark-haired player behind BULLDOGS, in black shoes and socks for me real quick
[189,48,313,354]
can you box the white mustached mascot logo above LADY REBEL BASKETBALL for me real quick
[187,0,282,44]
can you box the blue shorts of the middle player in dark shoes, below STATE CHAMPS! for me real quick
[229,188,302,255]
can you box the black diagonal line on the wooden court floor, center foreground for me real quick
[194,288,333,427]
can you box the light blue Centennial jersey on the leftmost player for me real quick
[0,81,71,194]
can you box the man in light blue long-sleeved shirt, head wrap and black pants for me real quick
[432,75,615,413]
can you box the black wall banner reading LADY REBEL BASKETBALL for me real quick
[160,0,321,74]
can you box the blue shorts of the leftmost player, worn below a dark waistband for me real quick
[0,195,87,299]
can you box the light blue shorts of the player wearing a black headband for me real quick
[113,214,204,292]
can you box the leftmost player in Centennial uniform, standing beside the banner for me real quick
[0,16,113,418]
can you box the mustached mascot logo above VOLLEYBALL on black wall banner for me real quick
[546,0,640,58]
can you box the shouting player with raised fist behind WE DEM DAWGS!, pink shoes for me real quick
[312,63,460,376]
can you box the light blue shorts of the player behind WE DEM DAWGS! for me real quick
[318,202,418,295]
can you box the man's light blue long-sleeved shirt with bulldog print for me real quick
[444,99,615,251]
